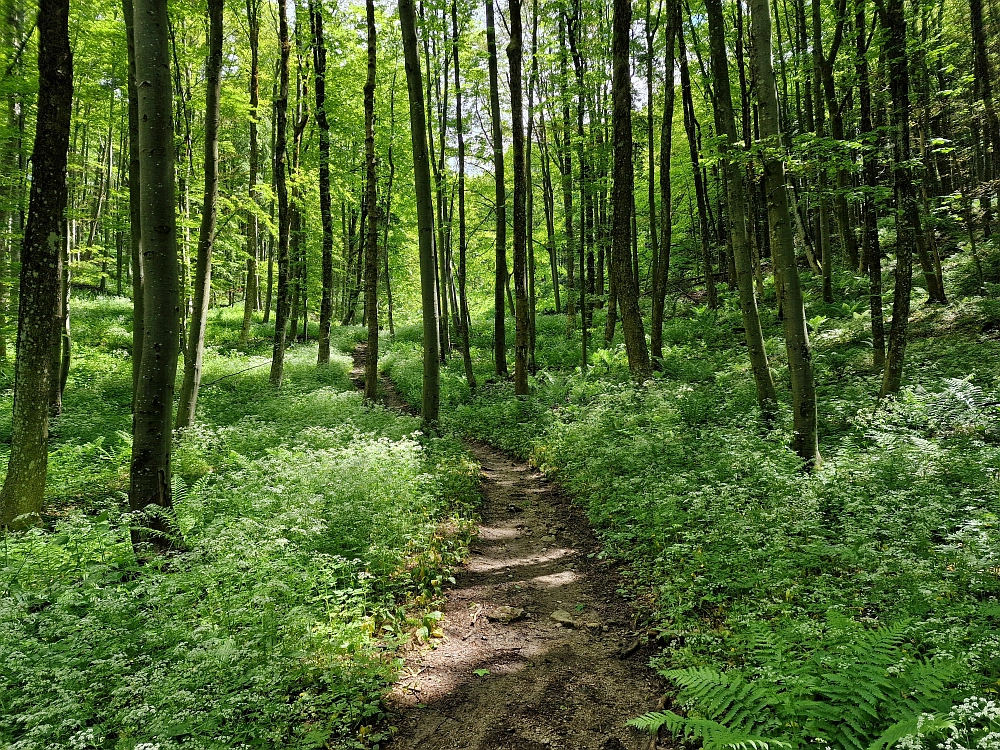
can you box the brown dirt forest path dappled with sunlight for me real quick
[352,345,661,750]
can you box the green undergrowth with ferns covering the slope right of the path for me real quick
[381,256,1000,750]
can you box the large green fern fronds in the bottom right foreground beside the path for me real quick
[633,615,959,750]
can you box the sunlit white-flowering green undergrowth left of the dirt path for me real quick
[0,299,475,750]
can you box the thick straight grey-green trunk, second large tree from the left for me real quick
[129,0,181,547]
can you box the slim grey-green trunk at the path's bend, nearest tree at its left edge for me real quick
[399,0,438,431]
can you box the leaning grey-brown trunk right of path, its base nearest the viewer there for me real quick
[750,0,820,470]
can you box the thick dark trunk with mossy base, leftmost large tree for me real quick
[0,0,73,526]
